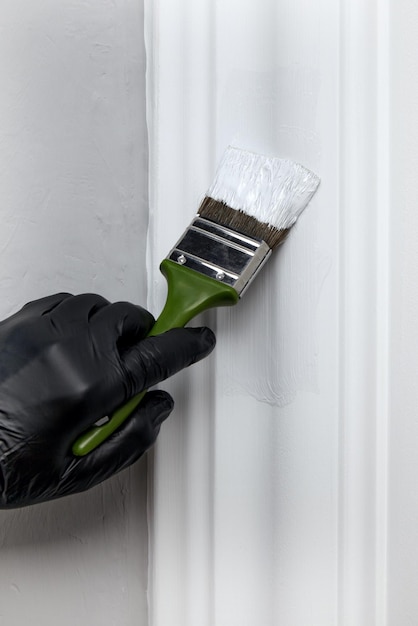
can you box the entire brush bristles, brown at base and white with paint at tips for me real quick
[204,147,320,248]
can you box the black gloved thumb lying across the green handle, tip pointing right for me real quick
[122,327,216,395]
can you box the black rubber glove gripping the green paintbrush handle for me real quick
[0,294,215,508]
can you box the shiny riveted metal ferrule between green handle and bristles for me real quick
[167,215,271,296]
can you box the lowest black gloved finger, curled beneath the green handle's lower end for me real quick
[63,391,174,493]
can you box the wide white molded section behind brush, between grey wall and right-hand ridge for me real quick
[146,0,340,626]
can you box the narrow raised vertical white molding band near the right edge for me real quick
[338,0,390,626]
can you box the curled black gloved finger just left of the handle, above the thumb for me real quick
[91,302,155,353]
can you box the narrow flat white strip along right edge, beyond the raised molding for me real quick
[387,0,418,626]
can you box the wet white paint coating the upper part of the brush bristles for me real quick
[206,146,320,229]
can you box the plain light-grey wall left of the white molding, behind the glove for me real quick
[0,0,148,626]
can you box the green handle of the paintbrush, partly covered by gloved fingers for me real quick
[73,259,239,456]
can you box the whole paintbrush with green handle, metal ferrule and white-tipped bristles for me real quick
[73,147,319,456]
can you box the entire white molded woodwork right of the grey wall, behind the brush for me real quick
[146,0,418,626]
